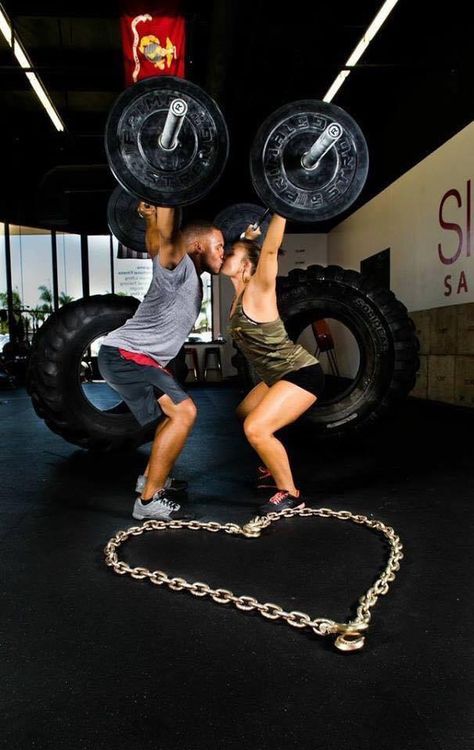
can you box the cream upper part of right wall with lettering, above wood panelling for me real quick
[328,123,474,311]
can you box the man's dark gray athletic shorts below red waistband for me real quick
[98,344,189,425]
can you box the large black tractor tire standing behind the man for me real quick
[27,294,187,451]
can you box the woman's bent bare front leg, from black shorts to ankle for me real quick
[244,380,316,496]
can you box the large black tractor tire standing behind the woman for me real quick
[232,266,419,439]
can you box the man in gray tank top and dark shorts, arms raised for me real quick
[99,202,224,520]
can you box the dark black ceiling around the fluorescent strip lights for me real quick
[0,0,474,234]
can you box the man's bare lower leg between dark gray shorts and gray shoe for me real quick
[142,395,197,500]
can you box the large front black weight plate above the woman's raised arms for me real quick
[250,99,369,222]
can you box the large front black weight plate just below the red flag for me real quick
[105,76,229,206]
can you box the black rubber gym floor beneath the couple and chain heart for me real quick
[0,387,474,750]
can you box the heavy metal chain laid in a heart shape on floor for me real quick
[104,508,403,651]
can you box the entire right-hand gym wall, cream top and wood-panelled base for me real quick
[328,123,474,407]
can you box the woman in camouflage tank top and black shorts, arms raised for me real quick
[221,215,324,513]
